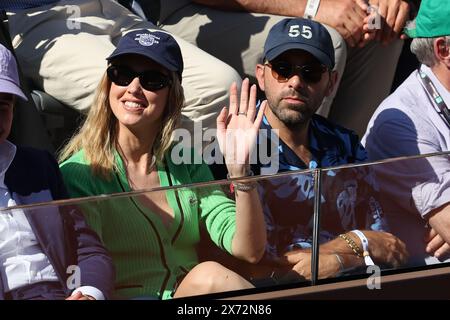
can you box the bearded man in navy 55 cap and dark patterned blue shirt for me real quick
[209,18,406,278]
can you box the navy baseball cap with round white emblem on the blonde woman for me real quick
[106,29,183,80]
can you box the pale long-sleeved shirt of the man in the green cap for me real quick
[361,65,450,263]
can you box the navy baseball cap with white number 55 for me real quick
[264,18,334,70]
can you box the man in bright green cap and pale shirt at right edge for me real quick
[362,0,450,263]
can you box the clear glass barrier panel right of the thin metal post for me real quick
[318,153,450,279]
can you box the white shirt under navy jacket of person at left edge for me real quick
[0,141,104,300]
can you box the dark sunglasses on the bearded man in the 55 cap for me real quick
[265,61,328,83]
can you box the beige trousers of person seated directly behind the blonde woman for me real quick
[8,0,241,136]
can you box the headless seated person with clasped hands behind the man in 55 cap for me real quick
[155,0,410,135]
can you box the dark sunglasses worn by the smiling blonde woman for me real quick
[106,65,172,91]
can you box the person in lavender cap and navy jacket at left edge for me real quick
[0,45,114,300]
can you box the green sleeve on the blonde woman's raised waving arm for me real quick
[190,159,236,254]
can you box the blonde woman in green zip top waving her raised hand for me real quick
[60,30,266,299]
